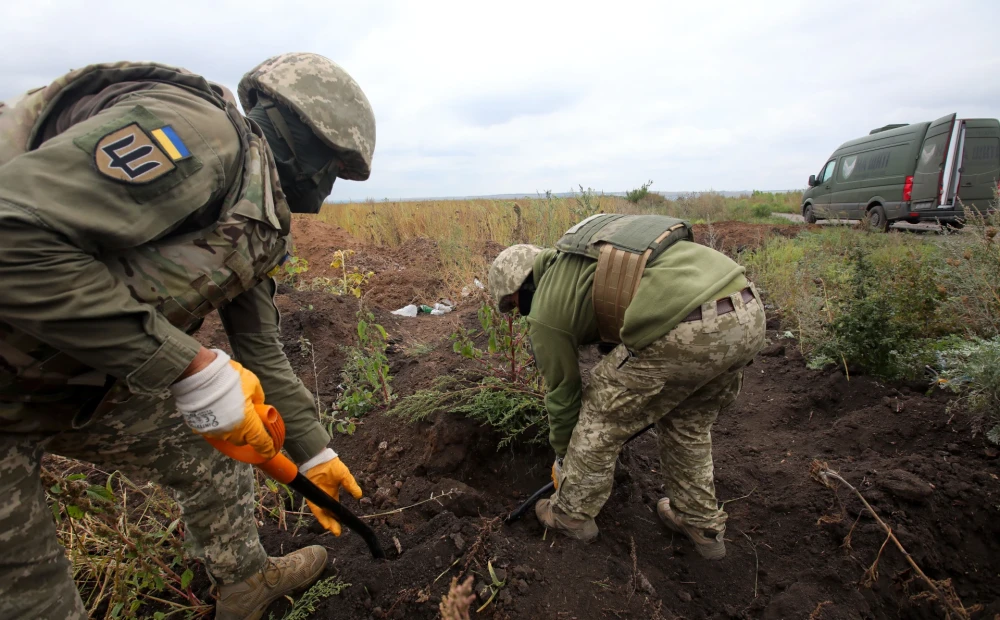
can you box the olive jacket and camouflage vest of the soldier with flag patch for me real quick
[0,63,329,461]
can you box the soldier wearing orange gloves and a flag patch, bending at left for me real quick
[0,54,375,619]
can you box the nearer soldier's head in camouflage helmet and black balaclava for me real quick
[237,53,375,213]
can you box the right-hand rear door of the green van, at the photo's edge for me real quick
[958,118,1000,210]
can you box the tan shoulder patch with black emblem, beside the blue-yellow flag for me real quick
[94,123,180,184]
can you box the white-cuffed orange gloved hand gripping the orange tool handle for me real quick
[170,349,277,458]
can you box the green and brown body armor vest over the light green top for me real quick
[556,213,694,343]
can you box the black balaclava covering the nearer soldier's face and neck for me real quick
[247,97,340,213]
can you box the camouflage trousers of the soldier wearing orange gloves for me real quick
[0,397,267,619]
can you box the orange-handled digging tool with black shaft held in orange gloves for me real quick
[205,405,385,560]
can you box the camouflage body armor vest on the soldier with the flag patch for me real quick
[0,62,291,402]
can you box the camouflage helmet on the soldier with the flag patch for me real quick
[237,53,375,181]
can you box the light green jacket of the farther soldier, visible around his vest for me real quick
[527,241,747,456]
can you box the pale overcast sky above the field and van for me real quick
[0,0,1000,200]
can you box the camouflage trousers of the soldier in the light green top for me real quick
[553,289,765,531]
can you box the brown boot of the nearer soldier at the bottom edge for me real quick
[215,545,326,620]
